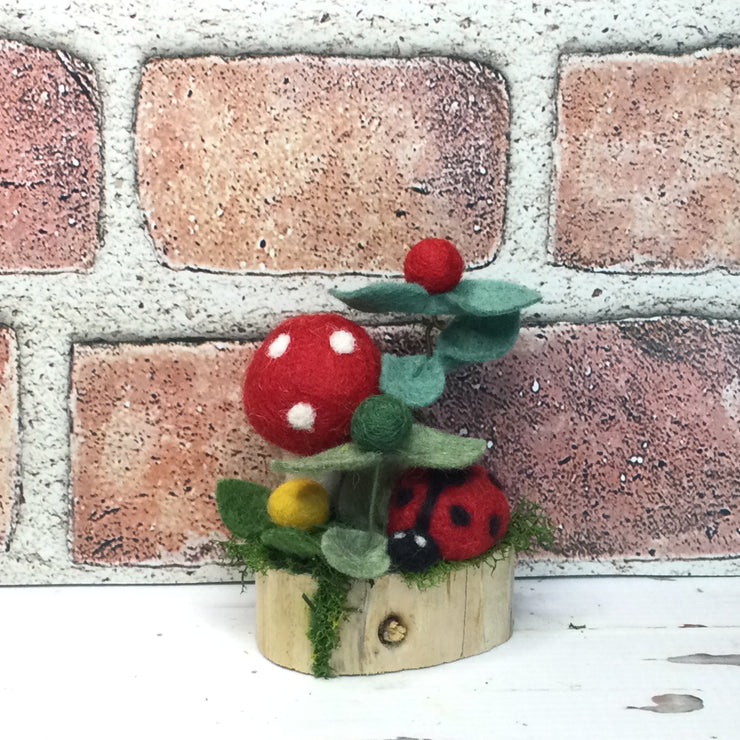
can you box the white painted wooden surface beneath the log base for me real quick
[0,577,740,740]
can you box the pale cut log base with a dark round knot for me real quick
[256,551,515,675]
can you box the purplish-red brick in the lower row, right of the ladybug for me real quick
[410,319,740,560]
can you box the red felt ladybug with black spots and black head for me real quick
[386,465,510,572]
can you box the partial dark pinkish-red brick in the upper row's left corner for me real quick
[0,41,101,272]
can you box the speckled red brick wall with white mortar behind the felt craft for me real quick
[0,0,740,583]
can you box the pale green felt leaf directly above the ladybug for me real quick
[397,424,486,468]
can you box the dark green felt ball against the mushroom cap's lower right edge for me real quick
[350,393,413,452]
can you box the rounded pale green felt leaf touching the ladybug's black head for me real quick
[321,527,391,578]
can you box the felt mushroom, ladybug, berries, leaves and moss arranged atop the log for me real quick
[216,239,551,676]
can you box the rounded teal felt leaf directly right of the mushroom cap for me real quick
[380,354,445,406]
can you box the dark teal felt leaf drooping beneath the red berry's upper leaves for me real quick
[434,312,519,370]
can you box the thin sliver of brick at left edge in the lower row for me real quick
[0,329,18,550]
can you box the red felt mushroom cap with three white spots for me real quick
[242,313,380,455]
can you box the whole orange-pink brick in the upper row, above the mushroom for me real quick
[136,56,508,271]
